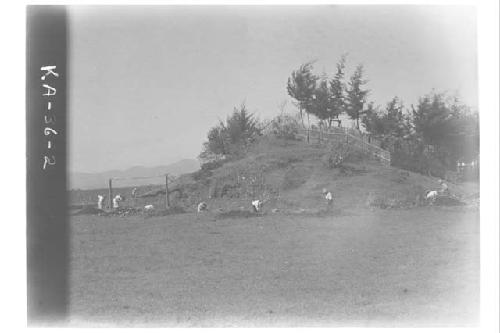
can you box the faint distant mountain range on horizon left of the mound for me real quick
[68,159,200,190]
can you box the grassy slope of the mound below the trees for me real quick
[68,137,479,213]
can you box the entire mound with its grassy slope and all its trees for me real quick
[72,56,479,213]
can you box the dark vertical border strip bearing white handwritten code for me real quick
[26,6,68,325]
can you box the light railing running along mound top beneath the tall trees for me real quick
[299,127,391,166]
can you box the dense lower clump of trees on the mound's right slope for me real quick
[363,92,479,177]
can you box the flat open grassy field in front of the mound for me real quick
[70,207,479,327]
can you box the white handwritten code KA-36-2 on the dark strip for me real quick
[40,65,59,170]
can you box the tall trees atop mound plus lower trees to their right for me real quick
[287,55,479,177]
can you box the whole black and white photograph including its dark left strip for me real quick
[19,4,498,328]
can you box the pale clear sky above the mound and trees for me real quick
[69,5,478,172]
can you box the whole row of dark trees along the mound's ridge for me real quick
[200,55,479,176]
